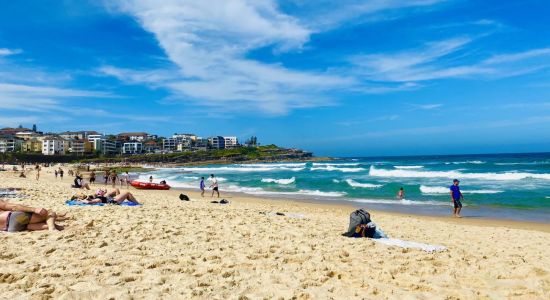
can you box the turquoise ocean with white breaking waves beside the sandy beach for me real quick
[140,153,550,222]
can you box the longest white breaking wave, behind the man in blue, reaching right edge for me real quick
[369,166,550,181]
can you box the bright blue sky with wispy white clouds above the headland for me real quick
[0,0,550,156]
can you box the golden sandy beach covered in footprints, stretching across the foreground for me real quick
[0,168,550,299]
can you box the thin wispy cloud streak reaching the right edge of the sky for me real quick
[352,37,550,82]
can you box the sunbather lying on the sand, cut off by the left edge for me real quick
[0,200,66,232]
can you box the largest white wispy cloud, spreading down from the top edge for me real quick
[100,0,364,114]
